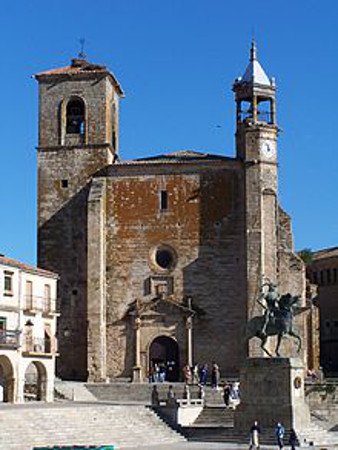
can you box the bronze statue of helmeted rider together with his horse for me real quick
[246,281,308,357]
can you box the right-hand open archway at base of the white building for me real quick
[24,361,47,401]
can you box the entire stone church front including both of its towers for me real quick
[36,44,307,381]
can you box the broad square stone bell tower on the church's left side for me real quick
[35,58,123,380]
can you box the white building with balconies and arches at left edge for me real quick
[0,255,58,403]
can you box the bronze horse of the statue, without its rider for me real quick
[246,294,307,358]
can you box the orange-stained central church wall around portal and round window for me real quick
[99,162,246,377]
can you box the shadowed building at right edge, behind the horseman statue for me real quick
[307,247,338,376]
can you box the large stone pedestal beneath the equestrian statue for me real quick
[235,358,310,432]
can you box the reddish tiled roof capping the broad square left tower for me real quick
[35,58,123,96]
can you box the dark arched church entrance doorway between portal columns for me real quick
[149,336,180,382]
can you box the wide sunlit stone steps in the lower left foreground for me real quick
[0,403,185,450]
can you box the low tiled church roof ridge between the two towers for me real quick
[118,150,234,165]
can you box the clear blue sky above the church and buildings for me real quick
[0,0,338,263]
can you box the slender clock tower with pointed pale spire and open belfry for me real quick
[233,41,278,356]
